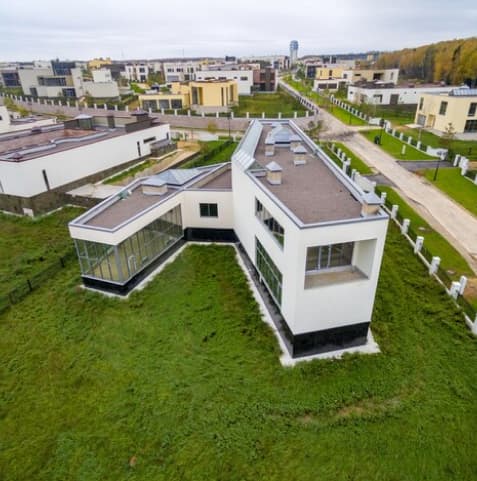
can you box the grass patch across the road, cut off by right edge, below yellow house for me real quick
[425,168,477,216]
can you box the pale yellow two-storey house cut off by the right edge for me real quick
[415,88,477,134]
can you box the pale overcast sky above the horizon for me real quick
[0,0,477,61]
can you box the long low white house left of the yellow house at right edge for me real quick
[348,82,456,105]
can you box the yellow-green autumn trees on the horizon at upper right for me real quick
[377,37,477,87]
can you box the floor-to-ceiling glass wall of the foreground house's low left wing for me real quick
[75,205,183,284]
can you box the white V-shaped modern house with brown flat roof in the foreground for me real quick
[69,120,388,357]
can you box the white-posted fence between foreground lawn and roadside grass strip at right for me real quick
[381,188,477,335]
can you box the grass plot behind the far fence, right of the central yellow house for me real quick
[233,89,305,117]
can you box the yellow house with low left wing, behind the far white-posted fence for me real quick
[138,80,238,113]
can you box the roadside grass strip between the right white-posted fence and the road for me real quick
[379,185,474,280]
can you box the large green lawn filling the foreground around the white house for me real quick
[0,226,477,481]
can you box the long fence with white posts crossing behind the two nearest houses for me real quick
[0,92,312,119]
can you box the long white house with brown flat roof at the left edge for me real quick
[0,112,170,214]
